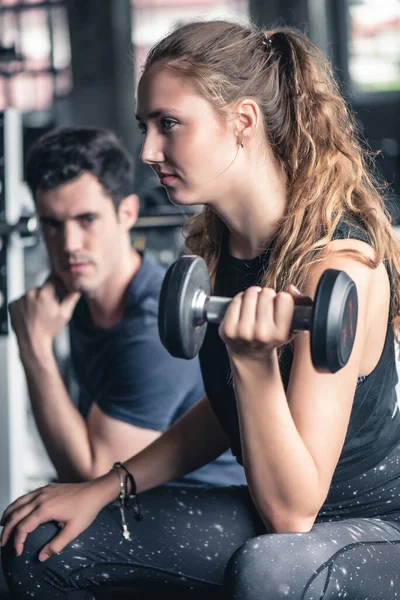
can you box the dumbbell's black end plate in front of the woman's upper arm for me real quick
[310,269,358,373]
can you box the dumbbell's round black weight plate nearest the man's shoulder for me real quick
[158,256,210,359]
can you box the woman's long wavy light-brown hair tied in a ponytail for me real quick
[144,20,400,337]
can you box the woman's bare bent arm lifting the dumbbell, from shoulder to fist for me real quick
[221,240,390,532]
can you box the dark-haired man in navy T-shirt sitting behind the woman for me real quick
[9,128,245,485]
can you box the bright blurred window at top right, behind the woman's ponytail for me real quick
[347,0,400,92]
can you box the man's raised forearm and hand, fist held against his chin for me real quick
[8,275,92,481]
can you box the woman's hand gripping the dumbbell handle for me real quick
[219,285,305,361]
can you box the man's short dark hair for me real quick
[25,127,133,209]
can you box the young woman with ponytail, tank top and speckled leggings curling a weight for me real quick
[2,21,400,600]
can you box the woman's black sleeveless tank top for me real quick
[199,222,400,483]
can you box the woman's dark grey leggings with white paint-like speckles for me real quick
[2,440,400,600]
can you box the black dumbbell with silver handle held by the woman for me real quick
[158,255,358,373]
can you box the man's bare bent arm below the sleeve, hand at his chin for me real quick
[9,280,159,481]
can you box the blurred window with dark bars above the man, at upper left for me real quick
[0,0,72,113]
